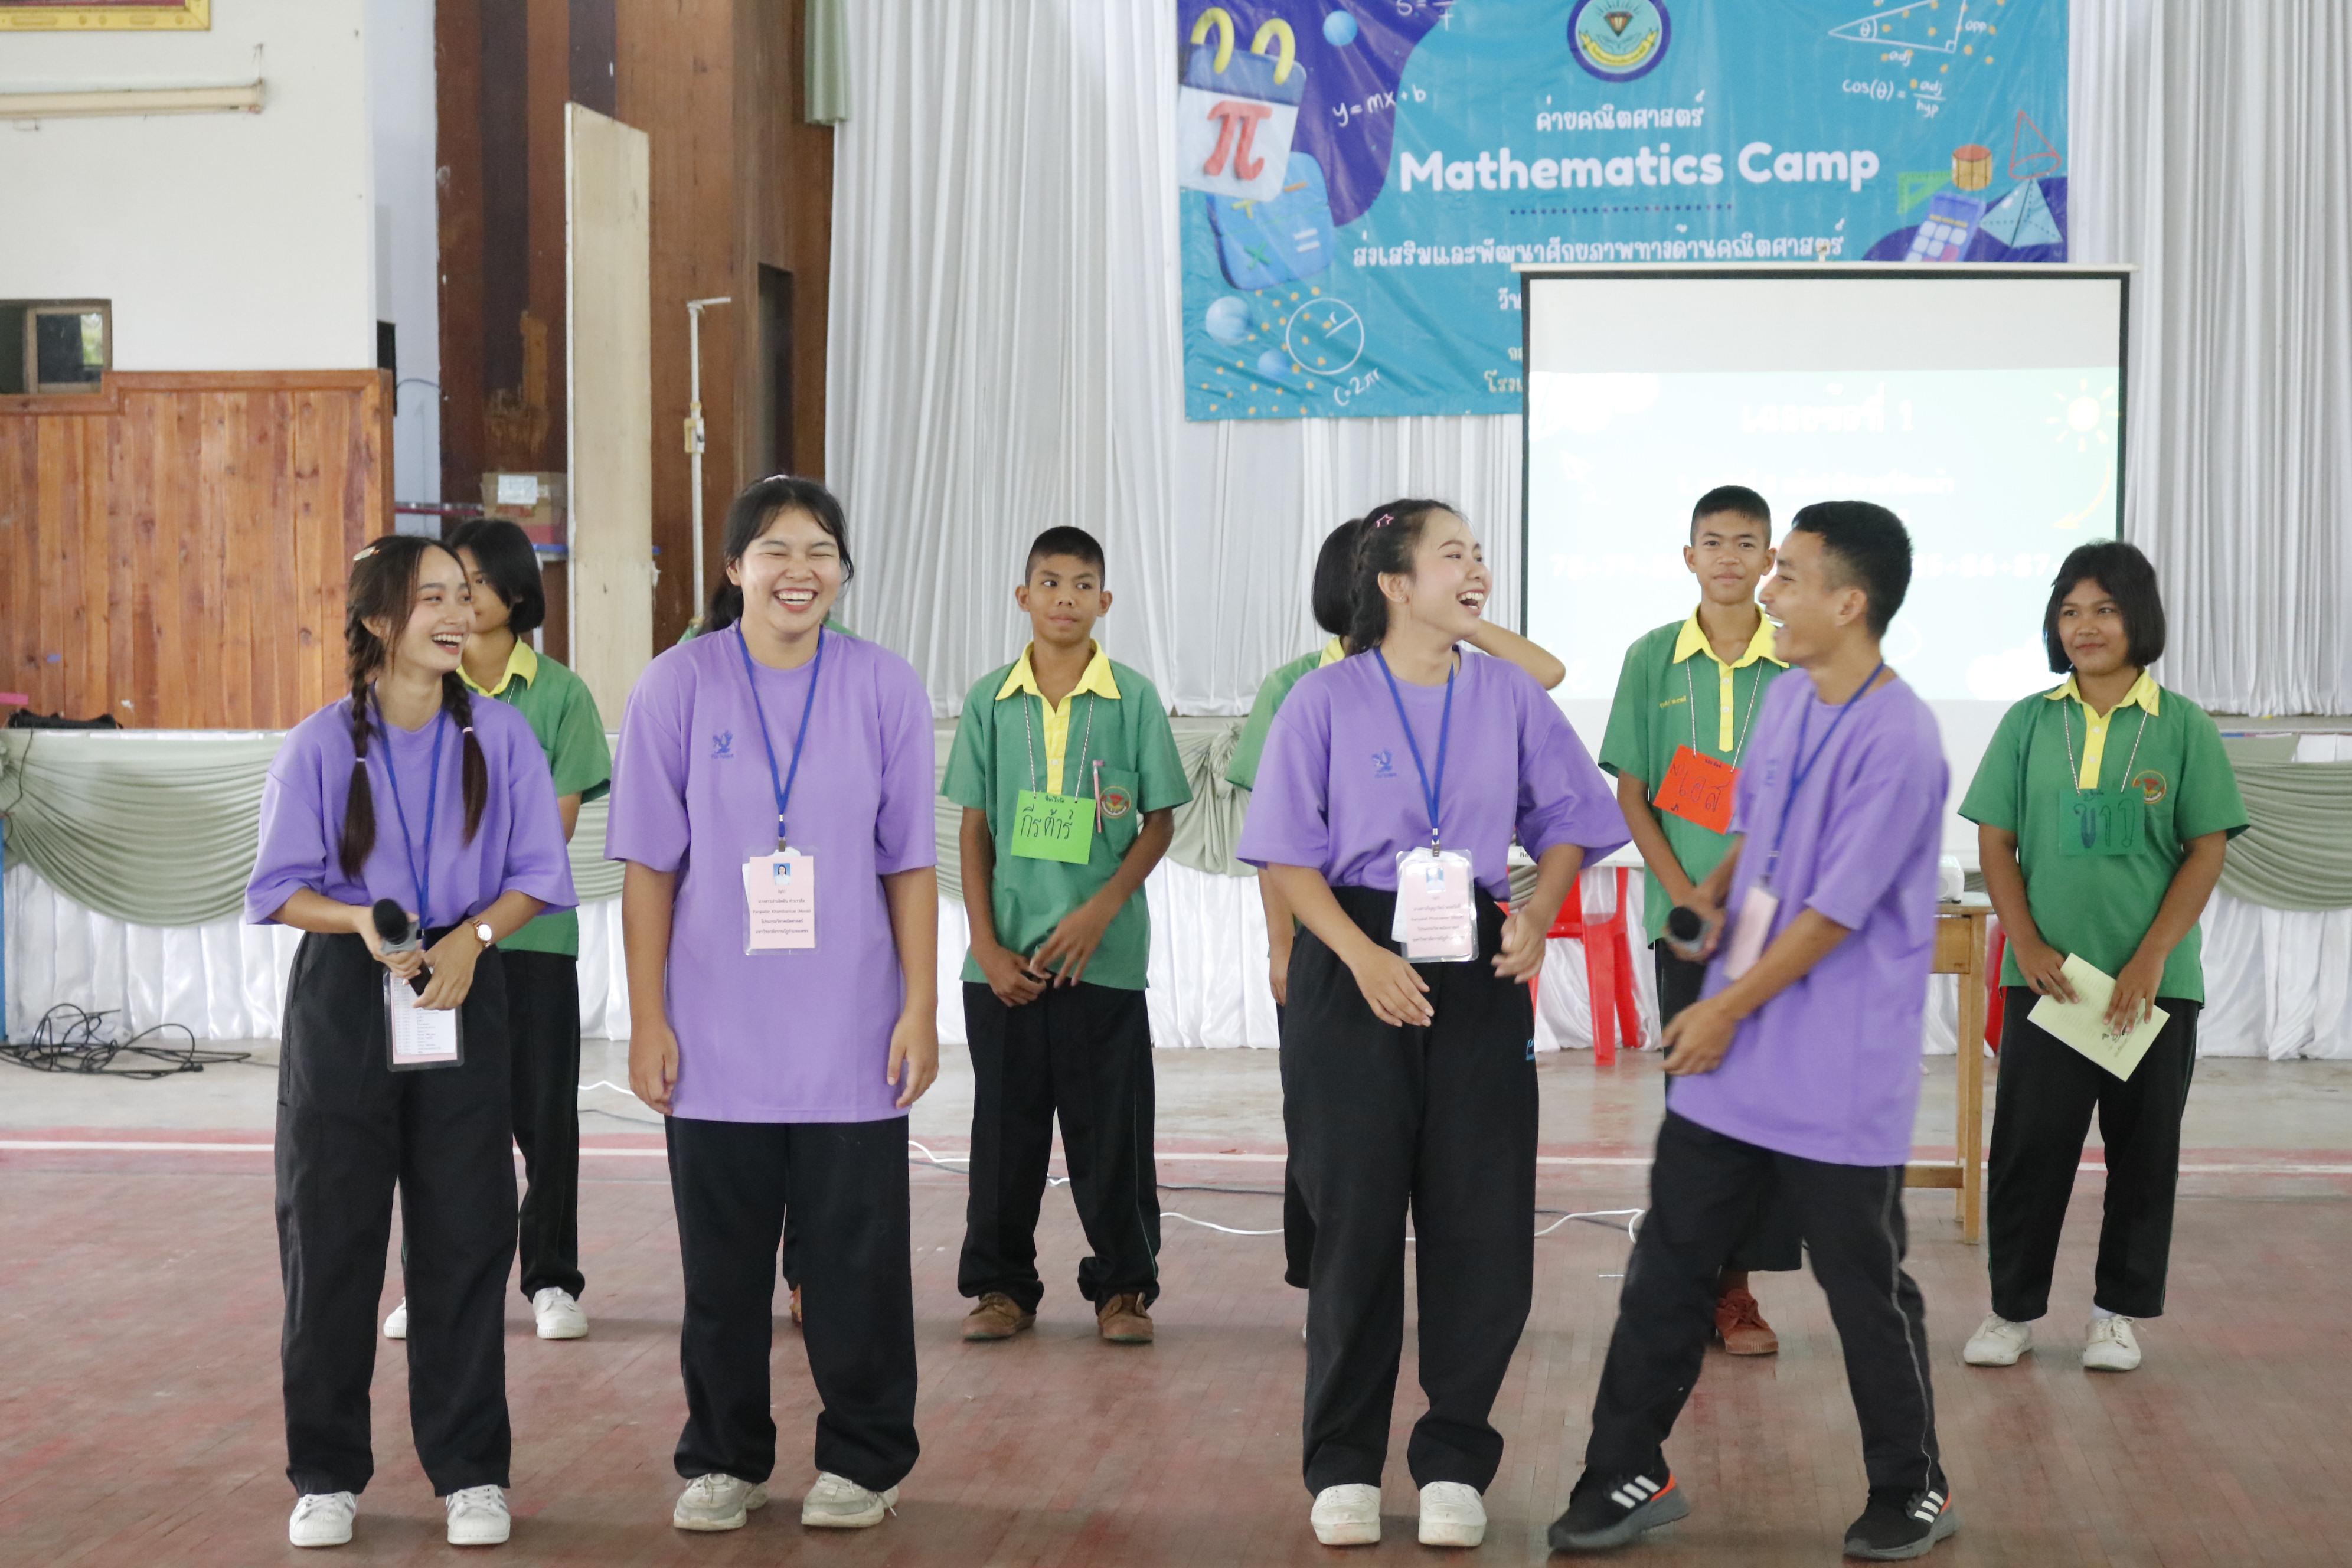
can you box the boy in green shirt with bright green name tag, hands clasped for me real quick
[941,527,1193,1345]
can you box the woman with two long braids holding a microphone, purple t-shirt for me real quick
[244,536,574,1547]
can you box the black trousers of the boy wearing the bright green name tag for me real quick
[955,980,1159,1312]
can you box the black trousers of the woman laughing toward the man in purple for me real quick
[1282,886,1536,1493]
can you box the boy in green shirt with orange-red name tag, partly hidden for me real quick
[1599,484,1804,1357]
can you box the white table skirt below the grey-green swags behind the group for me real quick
[0,863,2352,1067]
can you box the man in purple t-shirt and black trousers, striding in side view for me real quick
[1550,501,1959,1561]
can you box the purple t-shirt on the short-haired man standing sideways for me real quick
[1668,670,1950,1166]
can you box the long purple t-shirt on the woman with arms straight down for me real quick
[605,630,939,1121]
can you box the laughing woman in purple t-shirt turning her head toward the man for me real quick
[1240,501,1628,1547]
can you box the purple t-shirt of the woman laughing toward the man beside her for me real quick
[1237,651,1632,898]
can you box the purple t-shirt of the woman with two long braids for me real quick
[244,698,579,929]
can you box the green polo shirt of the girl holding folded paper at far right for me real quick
[1959,677,2246,1001]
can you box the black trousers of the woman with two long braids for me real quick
[277,931,515,1498]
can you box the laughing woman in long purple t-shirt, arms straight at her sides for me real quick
[605,477,939,1530]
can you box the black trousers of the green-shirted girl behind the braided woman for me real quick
[504,952,588,1300]
